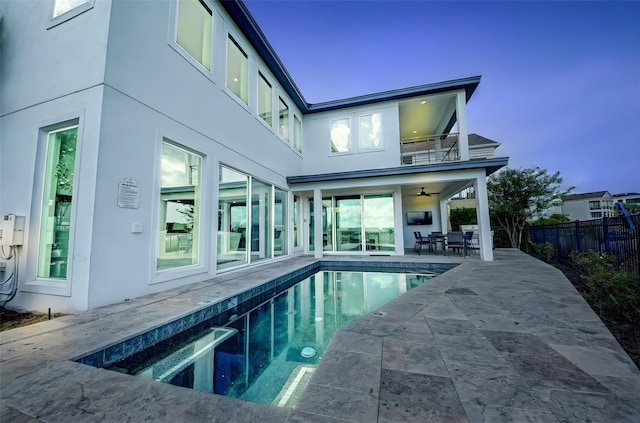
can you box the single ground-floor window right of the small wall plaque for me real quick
[157,141,201,270]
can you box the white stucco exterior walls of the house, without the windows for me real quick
[0,0,502,311]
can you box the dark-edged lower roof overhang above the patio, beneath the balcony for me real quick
[287,157,509,185]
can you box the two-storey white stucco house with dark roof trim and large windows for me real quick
[0,0,508,311]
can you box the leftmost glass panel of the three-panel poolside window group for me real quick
[217,166,249,270]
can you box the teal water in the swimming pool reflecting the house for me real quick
[108,271,436,407]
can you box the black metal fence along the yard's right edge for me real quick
[529,215,640,273]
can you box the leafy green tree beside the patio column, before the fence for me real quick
[487,166,573,249]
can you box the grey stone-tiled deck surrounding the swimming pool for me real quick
[0,250,640,423]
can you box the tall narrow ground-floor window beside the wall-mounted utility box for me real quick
[37,126,78,279]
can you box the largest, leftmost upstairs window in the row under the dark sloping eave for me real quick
[177,0,213,70]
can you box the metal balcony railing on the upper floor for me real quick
[400,134,460,165]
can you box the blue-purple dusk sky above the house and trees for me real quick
[245,0,640,194]
